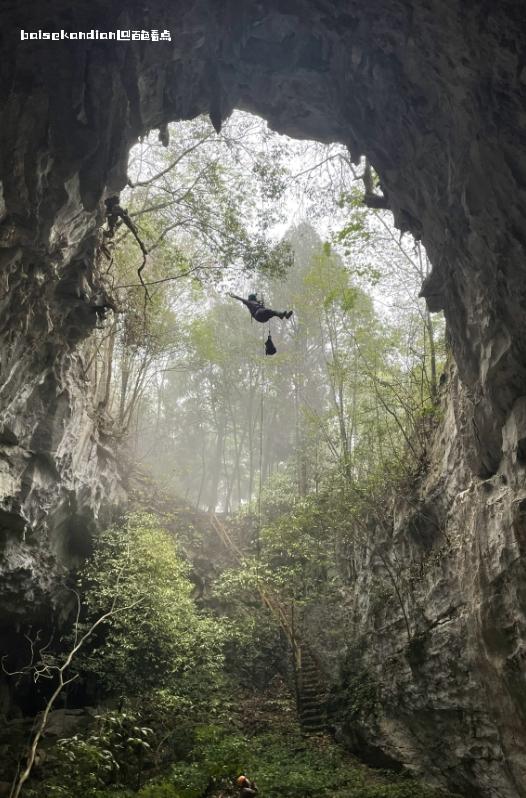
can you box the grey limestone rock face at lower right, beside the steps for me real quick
[333,369,526,798]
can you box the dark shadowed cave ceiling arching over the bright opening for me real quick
[5,0,526,476]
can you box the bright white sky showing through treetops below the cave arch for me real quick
[125,111,438,328]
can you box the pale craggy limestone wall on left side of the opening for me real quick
[0,230,123,642]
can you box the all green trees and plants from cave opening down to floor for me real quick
[4,113,454,798]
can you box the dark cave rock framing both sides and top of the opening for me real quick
[0,0,526,796]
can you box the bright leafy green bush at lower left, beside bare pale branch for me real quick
[80,514,224,708]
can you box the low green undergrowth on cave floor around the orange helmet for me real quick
[35,700,460,798]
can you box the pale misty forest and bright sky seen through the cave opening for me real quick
[90,112,444,512]
